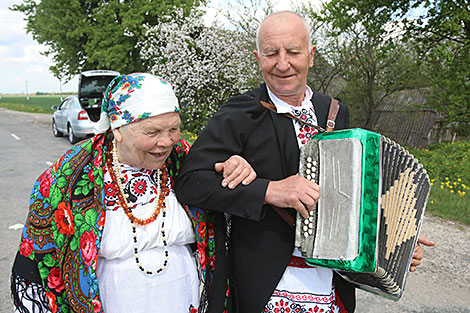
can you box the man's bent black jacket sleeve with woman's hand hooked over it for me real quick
[175,95,269,220]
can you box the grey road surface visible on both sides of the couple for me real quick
[0,108,470,313]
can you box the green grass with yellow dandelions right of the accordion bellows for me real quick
[408,140,470,225]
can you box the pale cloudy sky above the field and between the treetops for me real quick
[0,0,318,94]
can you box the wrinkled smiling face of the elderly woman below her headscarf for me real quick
[113,112,181,170]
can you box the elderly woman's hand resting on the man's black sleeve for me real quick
[214,155,256,189]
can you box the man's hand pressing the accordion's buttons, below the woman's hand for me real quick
[264,175,320,218]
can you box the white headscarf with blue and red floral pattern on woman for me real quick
[95,73,179,134]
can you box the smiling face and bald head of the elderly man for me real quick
[254,14,315,105]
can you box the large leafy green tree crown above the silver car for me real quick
[11,0,204,80]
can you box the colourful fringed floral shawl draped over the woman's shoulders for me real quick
[11,132,221,312]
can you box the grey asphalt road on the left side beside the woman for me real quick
[0,109,70,312]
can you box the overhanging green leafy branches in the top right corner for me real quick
[318,0,470,135]
